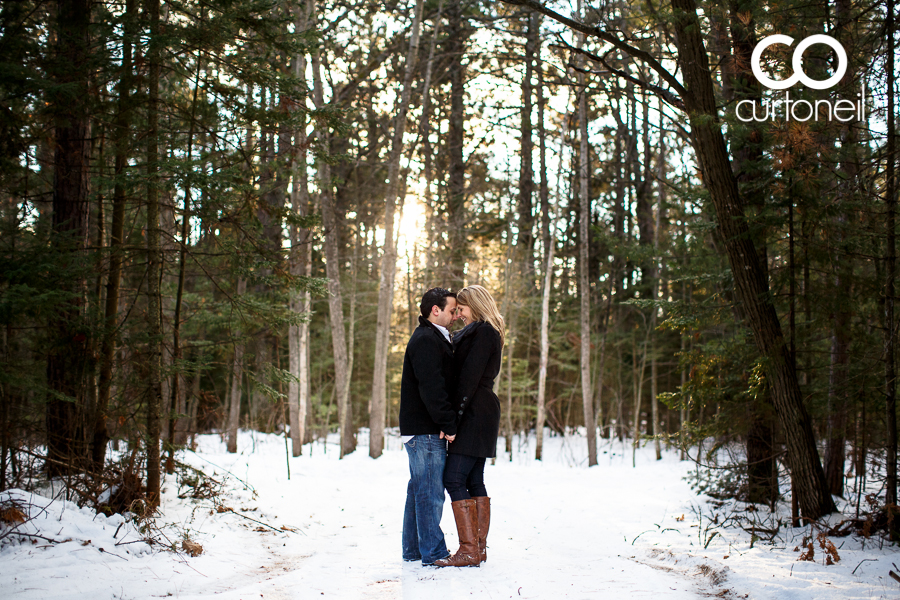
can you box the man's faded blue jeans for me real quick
[403,434,450,565]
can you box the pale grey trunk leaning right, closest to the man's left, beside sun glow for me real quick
[369,0,424,458]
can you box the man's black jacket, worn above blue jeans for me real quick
[400,317,457,435]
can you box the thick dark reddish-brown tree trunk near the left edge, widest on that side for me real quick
[46,0,91,477]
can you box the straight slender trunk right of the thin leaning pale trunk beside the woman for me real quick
[578,0,597,467]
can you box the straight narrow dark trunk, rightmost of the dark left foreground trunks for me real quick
[146,0,163,508]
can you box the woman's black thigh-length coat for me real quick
[448,321,503,458]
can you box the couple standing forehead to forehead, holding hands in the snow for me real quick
[400,285,503,567]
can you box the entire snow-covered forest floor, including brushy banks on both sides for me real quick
[0,432,900,600]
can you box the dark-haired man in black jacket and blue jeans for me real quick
[400,288,456,565]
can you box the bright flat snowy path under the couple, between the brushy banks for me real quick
[156,440,706,600]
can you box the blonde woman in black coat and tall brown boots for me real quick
[434,285,503,567]
